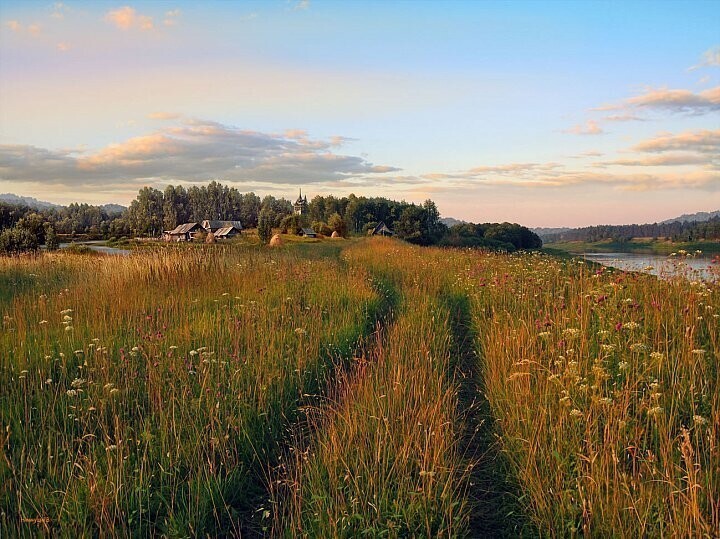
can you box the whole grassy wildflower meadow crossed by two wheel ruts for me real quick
[0,239,720,537]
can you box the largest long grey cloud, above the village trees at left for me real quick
[0,120,400,187]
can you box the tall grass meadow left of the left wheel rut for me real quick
[0,248,379,536]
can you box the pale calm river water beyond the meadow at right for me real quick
[578,252,720,280]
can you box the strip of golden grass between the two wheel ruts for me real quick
[277,240,467,537]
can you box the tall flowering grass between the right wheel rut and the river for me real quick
[466,255,720,537]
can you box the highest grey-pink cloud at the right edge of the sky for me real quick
[593,86,720,115]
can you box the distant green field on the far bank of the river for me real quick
[546,238,720,255]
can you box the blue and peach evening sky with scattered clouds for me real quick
[0,0,720,227]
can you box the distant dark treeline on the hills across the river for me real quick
[542,217,720,243]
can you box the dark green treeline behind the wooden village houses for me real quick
[0,182,542,252]
